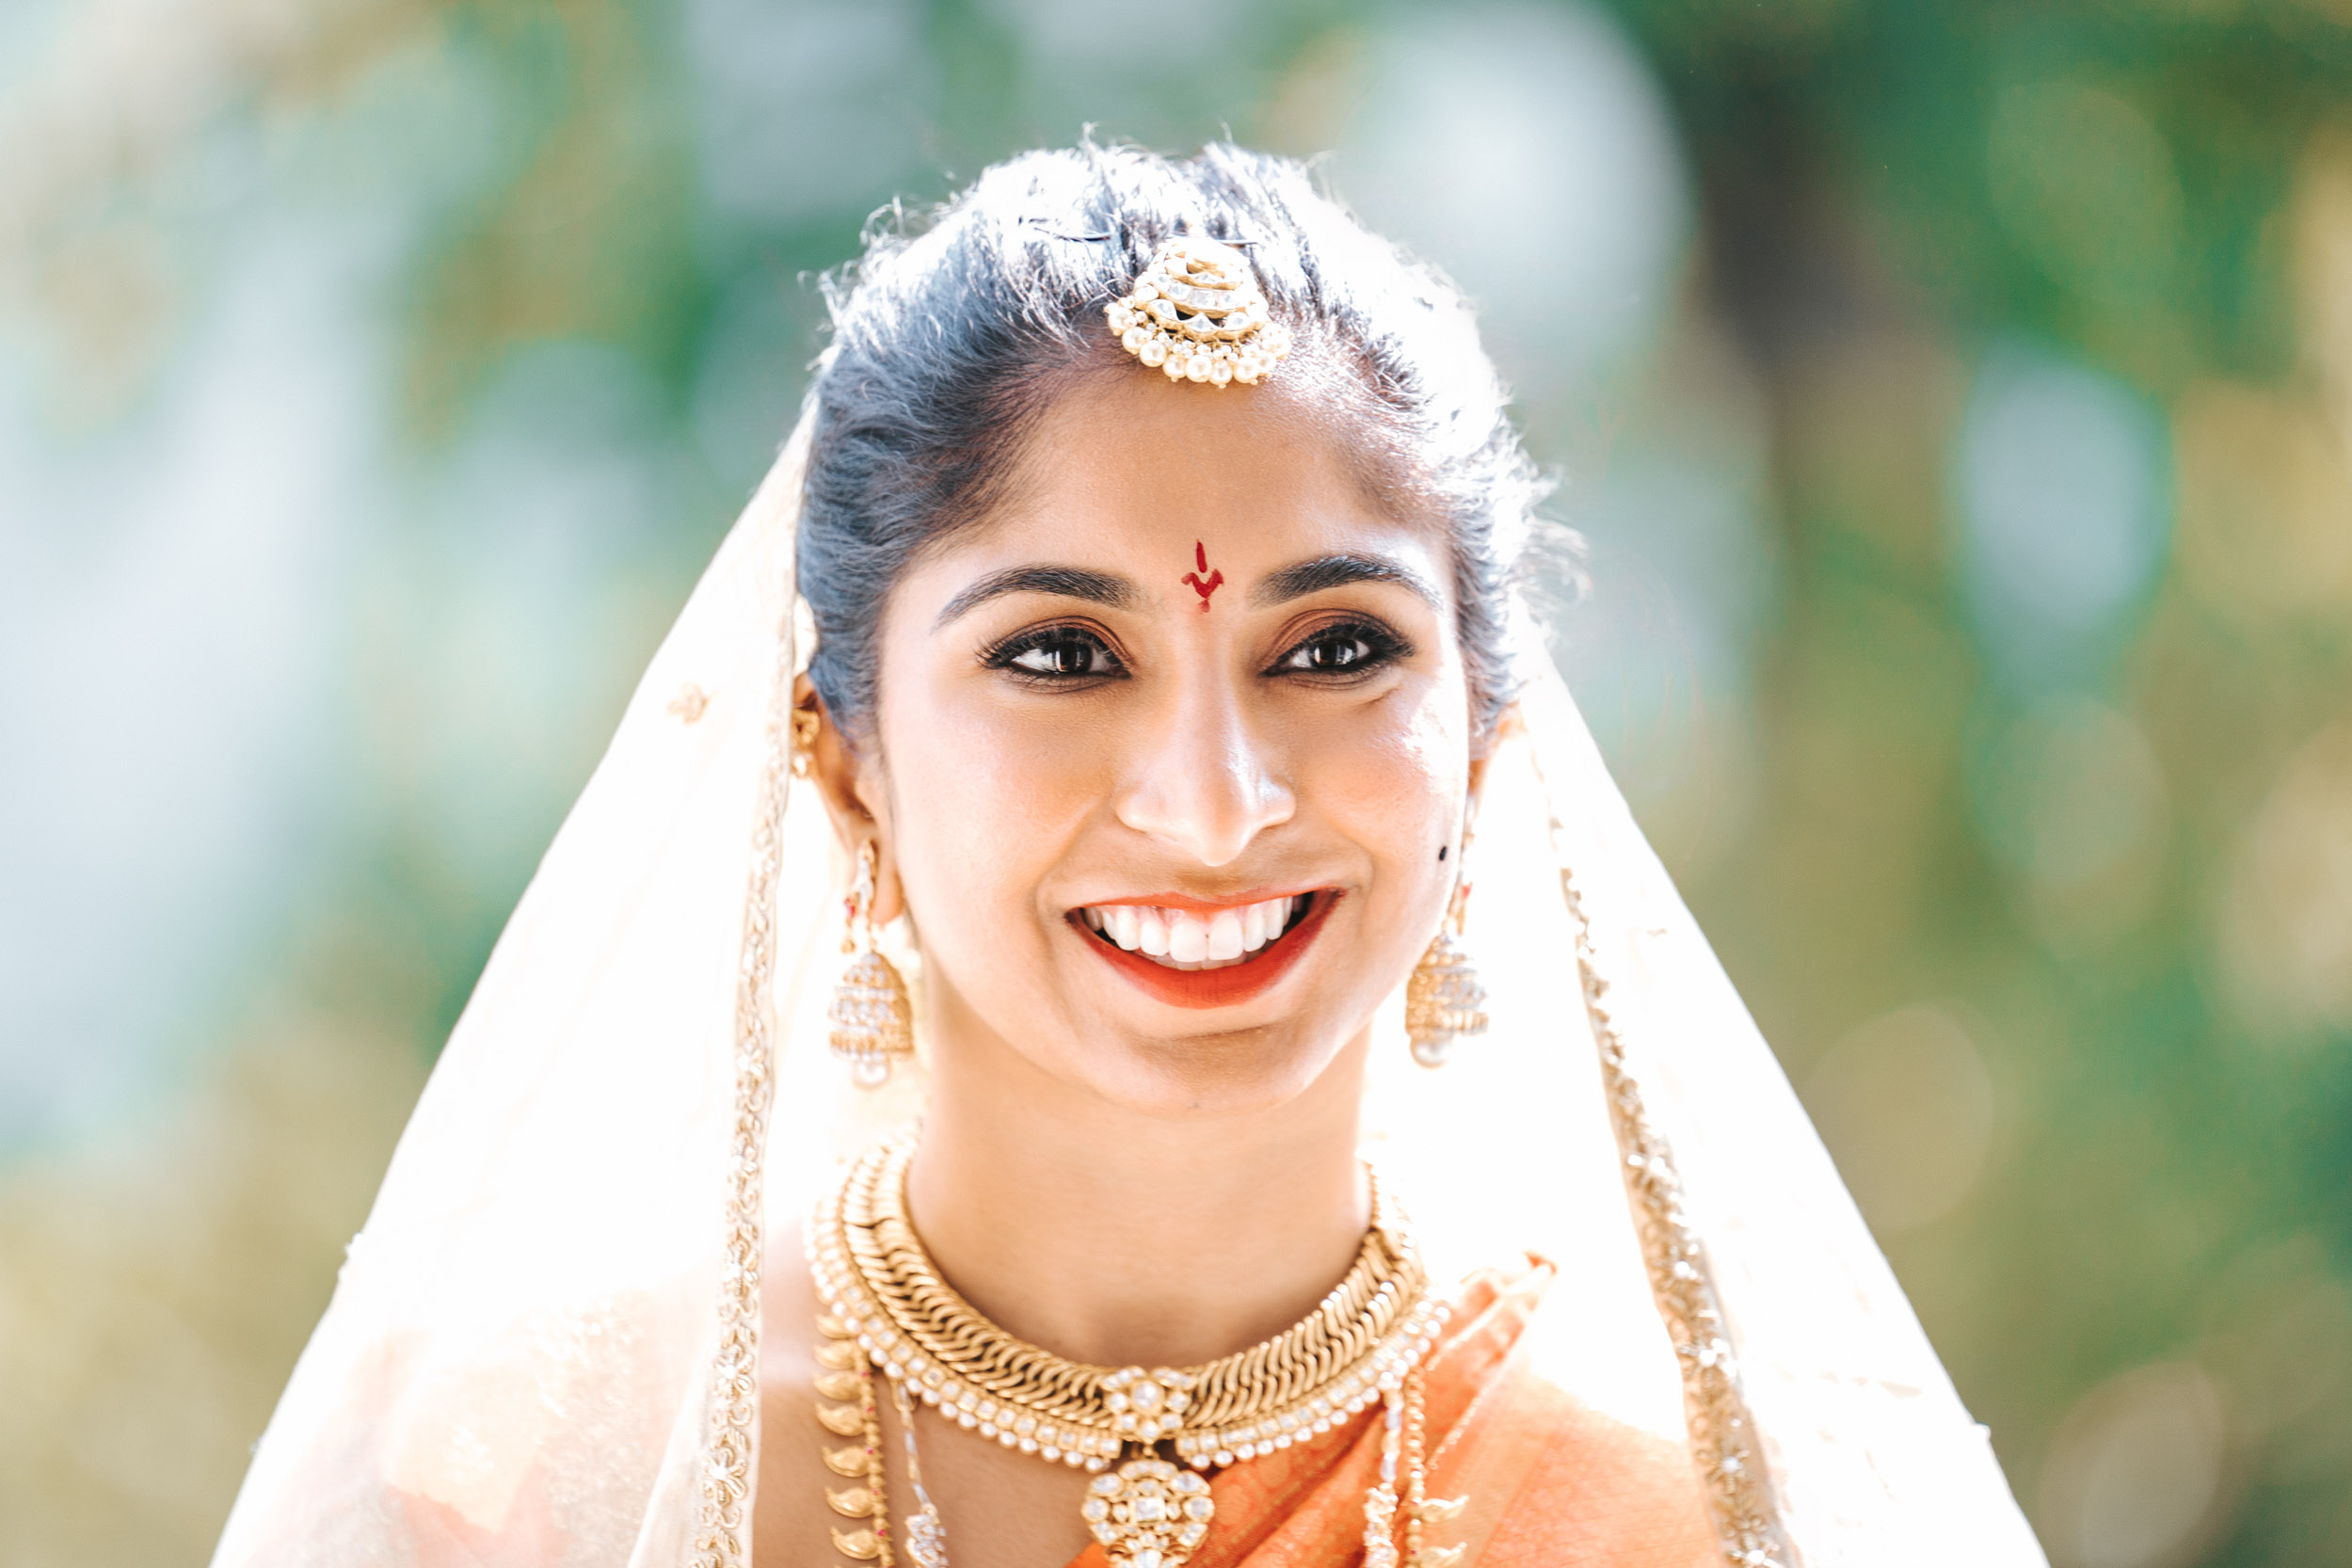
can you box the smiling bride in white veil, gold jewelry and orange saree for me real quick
[216,146,2040,1568]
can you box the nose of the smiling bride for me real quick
[1115,663,1298,868]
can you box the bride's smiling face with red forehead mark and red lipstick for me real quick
[856,374,1472,1114]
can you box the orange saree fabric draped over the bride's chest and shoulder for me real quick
[1070,1265,1721,1568]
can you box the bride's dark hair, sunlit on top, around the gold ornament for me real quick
[800,143,1545,736]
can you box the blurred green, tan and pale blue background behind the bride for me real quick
[0,0,2352,1568]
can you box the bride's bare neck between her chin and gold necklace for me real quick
[908,1006,1371,1366]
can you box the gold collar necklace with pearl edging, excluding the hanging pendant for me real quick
[809,1140,1447,1472]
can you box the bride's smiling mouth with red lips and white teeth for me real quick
[1070,888,1338,1009]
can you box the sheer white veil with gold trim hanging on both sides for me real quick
[214,421,2041,1568]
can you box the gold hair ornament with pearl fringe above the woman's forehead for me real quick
[1103,235,1291,386]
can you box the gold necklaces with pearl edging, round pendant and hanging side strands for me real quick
[807,1140,1448,1568]
